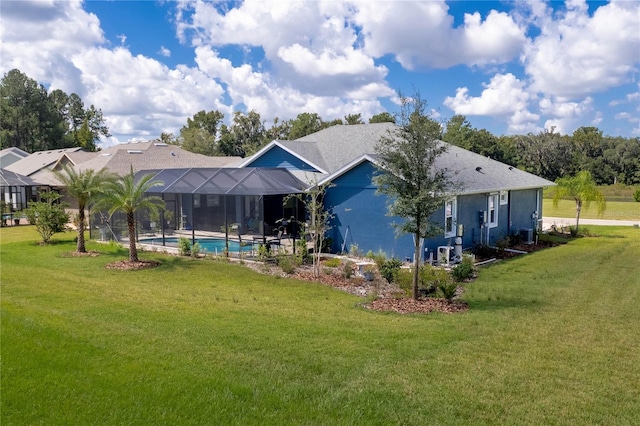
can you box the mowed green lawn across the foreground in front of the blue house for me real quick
[0,227,640,425]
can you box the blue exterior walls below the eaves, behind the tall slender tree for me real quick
[314,162,542,260]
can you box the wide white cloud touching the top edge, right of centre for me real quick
[354,1,526,69]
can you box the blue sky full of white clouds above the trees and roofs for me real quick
[0,0,640,146]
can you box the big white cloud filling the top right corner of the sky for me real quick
[522,0,640,99]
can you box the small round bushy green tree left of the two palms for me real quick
[24,192,69,244]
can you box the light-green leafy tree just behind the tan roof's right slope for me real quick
[179,110,224,156]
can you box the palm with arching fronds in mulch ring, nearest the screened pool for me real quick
[101,167,164,262]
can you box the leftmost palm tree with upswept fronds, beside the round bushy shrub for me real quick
[54,166,113,253]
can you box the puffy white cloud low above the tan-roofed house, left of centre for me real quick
[73,47,228,138]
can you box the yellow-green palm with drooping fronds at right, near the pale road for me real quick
[553,170,607,235]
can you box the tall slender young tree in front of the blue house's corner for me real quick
[374,94,454,299]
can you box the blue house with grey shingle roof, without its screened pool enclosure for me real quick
[240,123,554,260]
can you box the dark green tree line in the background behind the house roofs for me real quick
[0,70,640,185]
